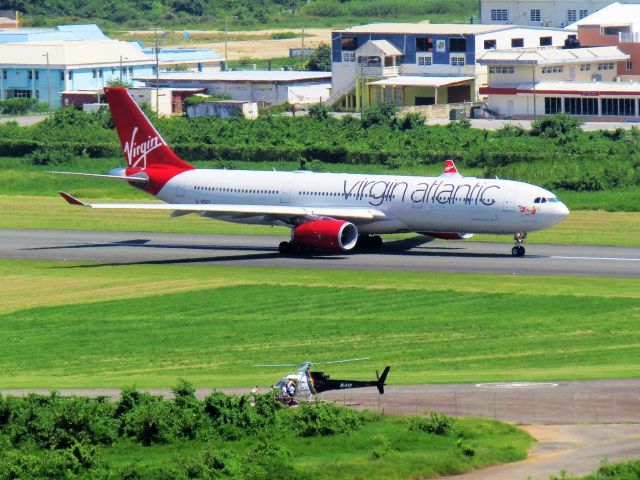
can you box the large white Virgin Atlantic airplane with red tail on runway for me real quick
[51,87,569,257]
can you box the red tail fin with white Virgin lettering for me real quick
[104,87,193,170]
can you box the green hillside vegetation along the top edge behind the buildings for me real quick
[0,0,477,29]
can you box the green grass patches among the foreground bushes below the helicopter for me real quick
[72,417,533,479]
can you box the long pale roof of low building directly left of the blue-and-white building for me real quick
[136,70,331,83]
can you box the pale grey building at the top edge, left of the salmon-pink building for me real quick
[480,0,624,28]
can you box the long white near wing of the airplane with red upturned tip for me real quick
[59,192,387,220]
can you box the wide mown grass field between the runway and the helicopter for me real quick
[0,261,640,388]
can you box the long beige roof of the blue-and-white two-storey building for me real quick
[334,23,513,35]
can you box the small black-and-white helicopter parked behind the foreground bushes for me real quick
[257,358,391,403]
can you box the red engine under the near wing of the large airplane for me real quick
[291,220,358,251]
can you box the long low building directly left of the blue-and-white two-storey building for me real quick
[135,70,331,107]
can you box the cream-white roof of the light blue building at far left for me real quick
[0,40,154,68]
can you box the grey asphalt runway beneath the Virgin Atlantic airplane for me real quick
[0,230,640,278]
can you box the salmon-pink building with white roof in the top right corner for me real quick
[568,2,640,80]
